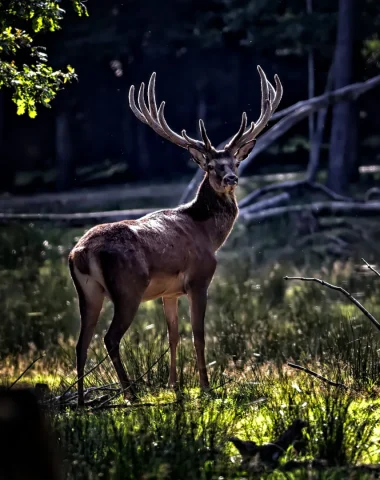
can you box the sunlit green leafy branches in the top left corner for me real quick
[0,0,87,118]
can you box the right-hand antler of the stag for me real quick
[224,65,283,153]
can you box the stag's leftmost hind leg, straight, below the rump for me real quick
[70,266,104,406]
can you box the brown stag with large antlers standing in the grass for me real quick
[69,66,282,405]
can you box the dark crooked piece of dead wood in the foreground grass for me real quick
[229,419,307,466]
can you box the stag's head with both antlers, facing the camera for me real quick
[129,66,283,193]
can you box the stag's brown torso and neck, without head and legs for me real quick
[70,174,238,301]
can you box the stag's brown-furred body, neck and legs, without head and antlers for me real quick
[69,171,238,404]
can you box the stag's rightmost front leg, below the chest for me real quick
[188,288,210,390]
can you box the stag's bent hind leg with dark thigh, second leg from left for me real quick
[100,252,149,399]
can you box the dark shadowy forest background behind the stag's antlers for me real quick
[0,0,380,193]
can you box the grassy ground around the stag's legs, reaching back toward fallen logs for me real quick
[0,175,380,480]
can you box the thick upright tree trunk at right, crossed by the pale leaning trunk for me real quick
[327,0,357,193]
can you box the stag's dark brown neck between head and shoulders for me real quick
[180,173,239,251]
